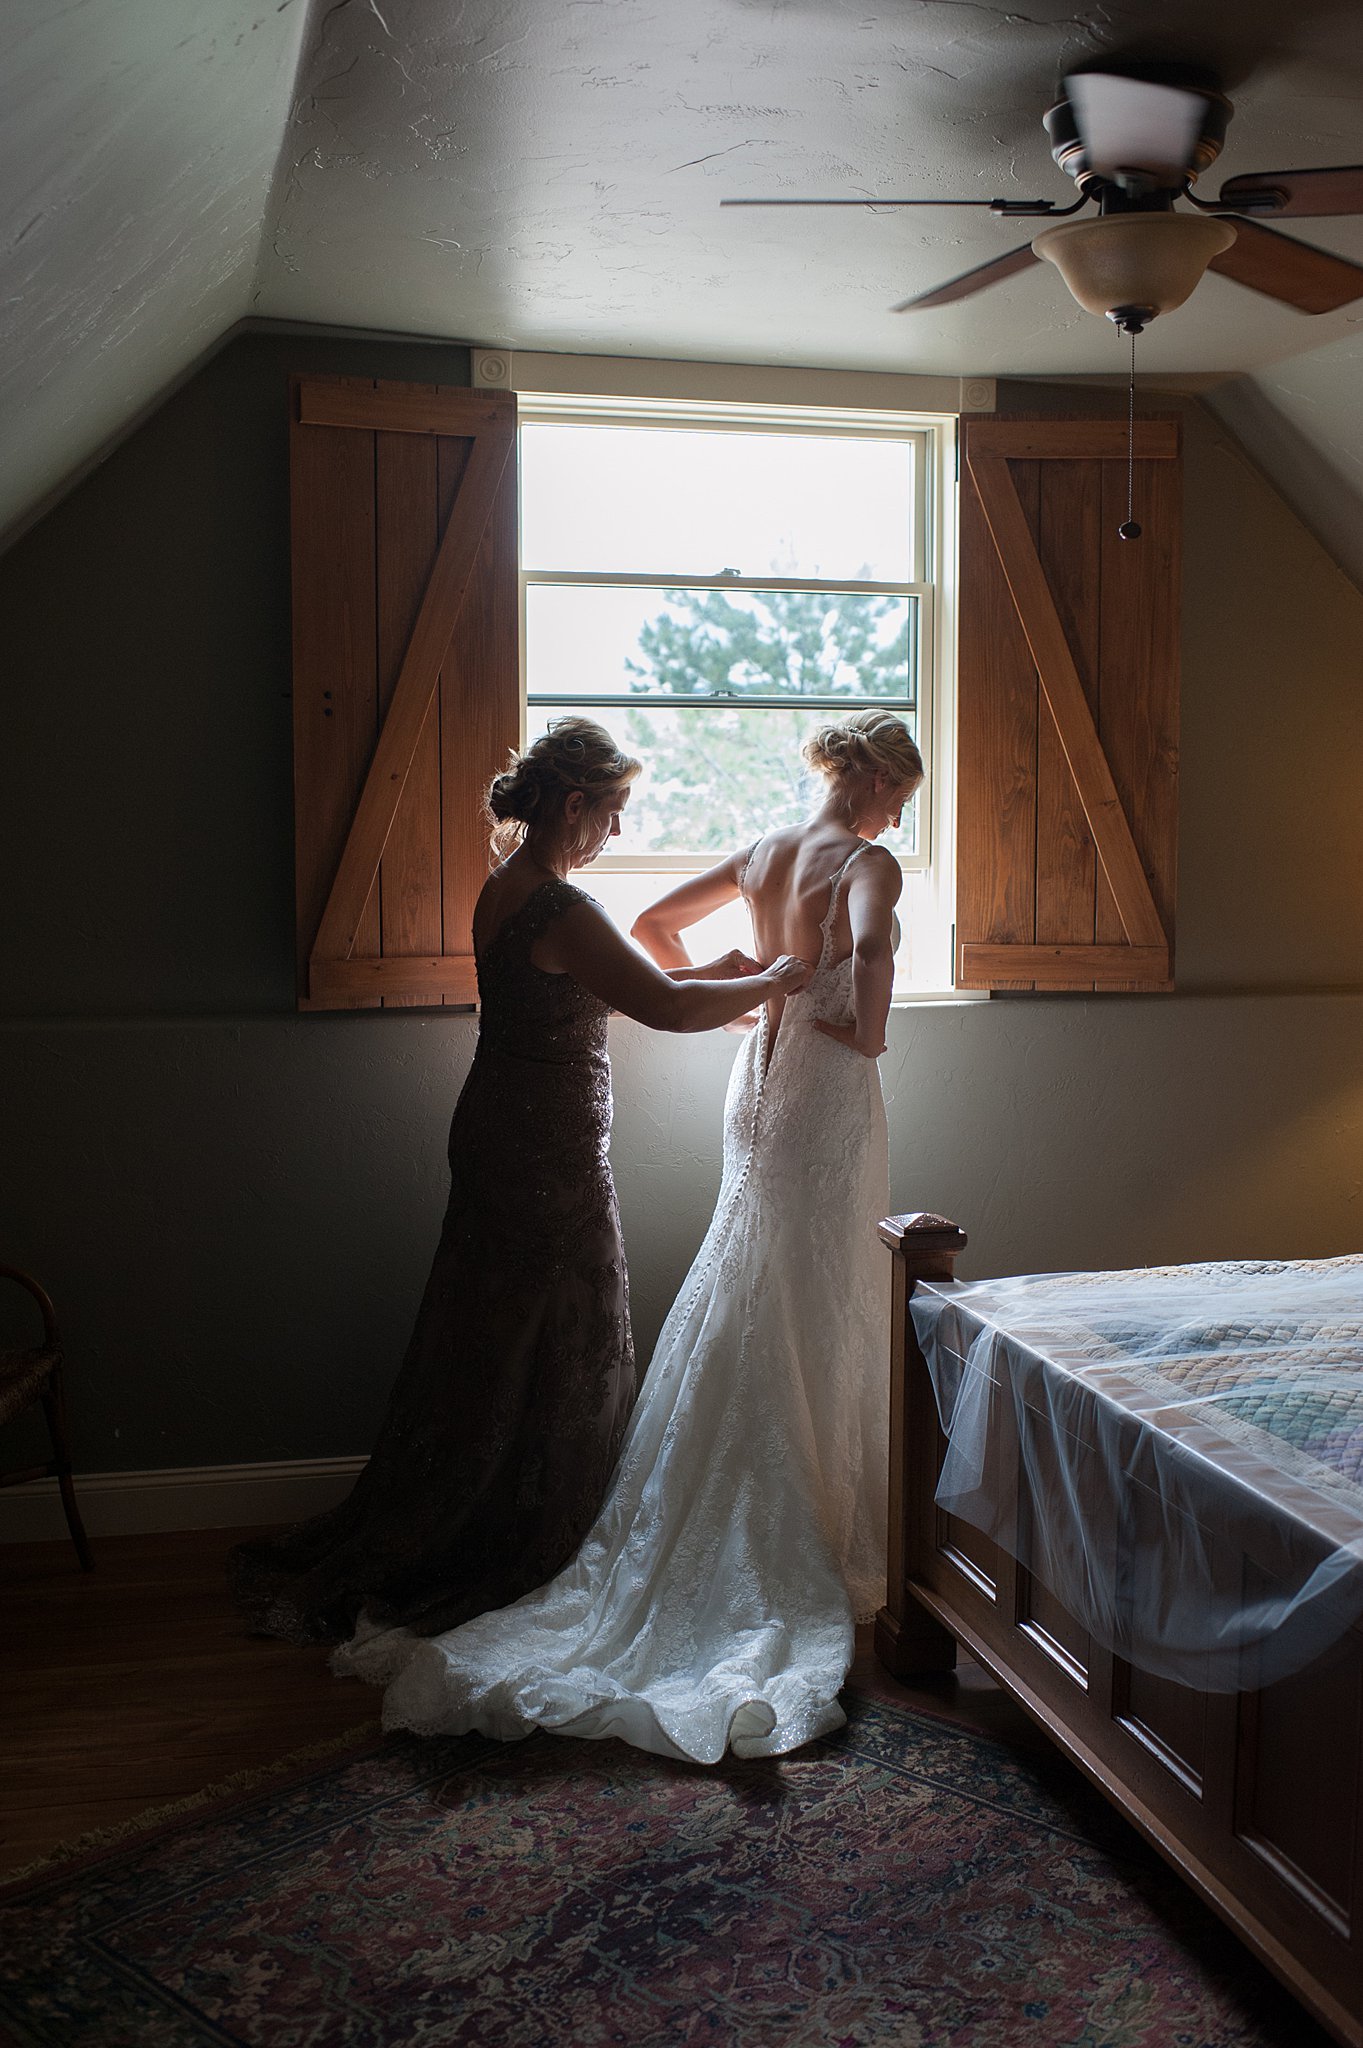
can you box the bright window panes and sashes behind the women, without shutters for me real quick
[520,393,939,985]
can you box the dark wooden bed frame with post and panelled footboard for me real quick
[876,1214,1363,2048]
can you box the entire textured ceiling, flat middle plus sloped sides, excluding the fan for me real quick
[0,0,1363,573]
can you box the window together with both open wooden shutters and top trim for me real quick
[289,372,1181,1010]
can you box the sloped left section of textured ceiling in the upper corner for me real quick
[0,0,305,532]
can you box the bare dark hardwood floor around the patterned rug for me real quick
[0,1530,1044,1876]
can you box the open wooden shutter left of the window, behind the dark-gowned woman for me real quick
[291,377,520,1010]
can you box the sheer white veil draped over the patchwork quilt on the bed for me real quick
[911,1255,1363,1690]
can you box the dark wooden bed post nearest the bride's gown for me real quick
[876,1210,966,1677]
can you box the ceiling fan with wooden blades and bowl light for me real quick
[720,63,1363,334]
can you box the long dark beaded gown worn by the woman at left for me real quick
[231,881,636,1642]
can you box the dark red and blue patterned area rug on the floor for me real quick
[0,1698,1324,2048]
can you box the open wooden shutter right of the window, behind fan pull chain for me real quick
[956,420,1181,989]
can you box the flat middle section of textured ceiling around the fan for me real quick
[251,0,1363,375]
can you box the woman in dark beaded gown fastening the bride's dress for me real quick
[231,719,808,1642]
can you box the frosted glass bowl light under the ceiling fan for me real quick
[1031,213,1236,319]
